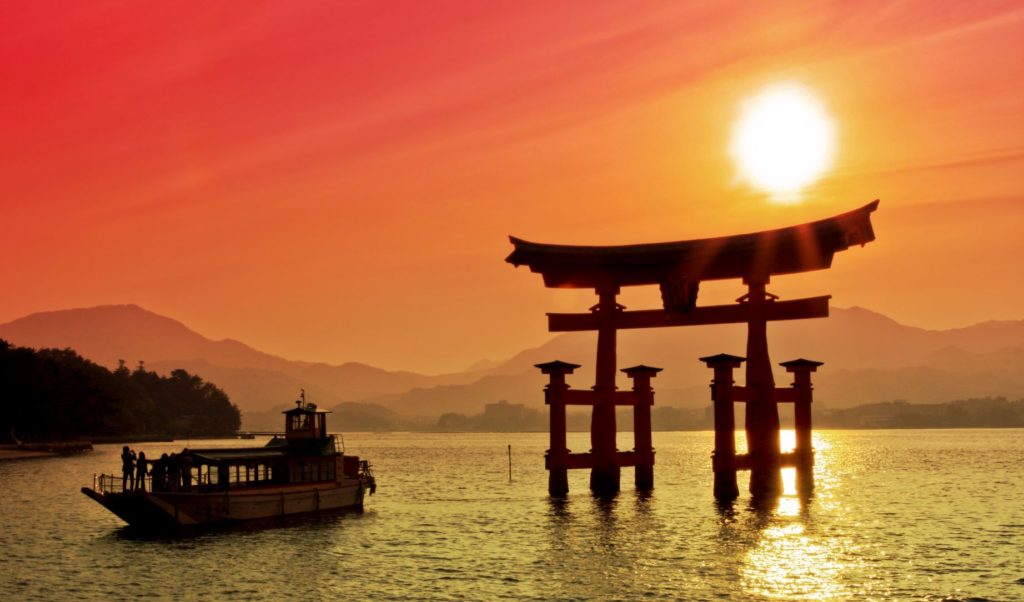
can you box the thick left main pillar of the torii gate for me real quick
[590,287,621,495]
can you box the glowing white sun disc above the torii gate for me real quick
[729,84,836,203]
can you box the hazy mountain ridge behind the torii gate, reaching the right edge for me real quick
[364,307,1024,414]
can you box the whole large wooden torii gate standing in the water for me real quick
[506,201,879,498]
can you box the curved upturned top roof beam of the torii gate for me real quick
[505,201,879,289]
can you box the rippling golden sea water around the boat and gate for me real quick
[0,429,1024,600]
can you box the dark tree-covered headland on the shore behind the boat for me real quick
[0,339,242,441]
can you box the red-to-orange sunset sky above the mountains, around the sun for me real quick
[0,0,1024,372]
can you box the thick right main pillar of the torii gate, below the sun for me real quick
[744,276,782,497]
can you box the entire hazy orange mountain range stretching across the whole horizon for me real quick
[0,305,1024,428]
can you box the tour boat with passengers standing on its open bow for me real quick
[82,391,377,530]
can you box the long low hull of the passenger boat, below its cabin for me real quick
[82,478,371,529]
